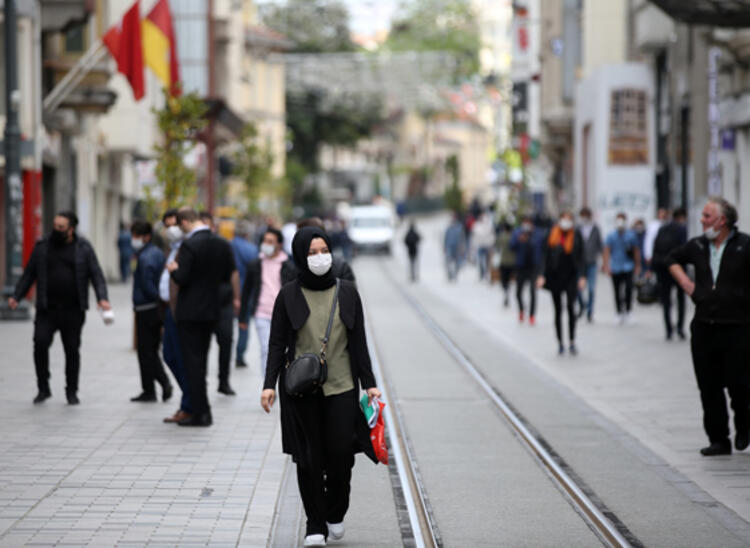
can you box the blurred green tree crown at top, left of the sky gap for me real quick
[263,0,356,53]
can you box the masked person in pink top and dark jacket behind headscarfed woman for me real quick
[238,228,297,375]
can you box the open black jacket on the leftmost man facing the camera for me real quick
[13,234,108,310]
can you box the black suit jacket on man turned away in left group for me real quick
[172,230,235,322]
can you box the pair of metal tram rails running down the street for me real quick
[376,264,643,548]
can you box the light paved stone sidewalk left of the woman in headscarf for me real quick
[0,285,287,548]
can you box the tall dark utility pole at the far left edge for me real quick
[0,0,29,319]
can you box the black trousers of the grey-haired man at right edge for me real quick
[690,320,750,443]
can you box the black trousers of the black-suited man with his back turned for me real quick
[177,322,216,416]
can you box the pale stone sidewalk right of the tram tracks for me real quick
[400,212,750,521]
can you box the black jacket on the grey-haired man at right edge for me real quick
[667,232,750,324]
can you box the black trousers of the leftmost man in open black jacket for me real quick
[34,309,86,393]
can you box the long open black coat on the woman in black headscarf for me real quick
[263,280,378,463]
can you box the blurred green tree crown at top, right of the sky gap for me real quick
[385,0,481,81]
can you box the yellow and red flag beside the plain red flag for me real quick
[142,0,180,96]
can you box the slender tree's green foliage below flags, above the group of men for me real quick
[146,89,208,217]
